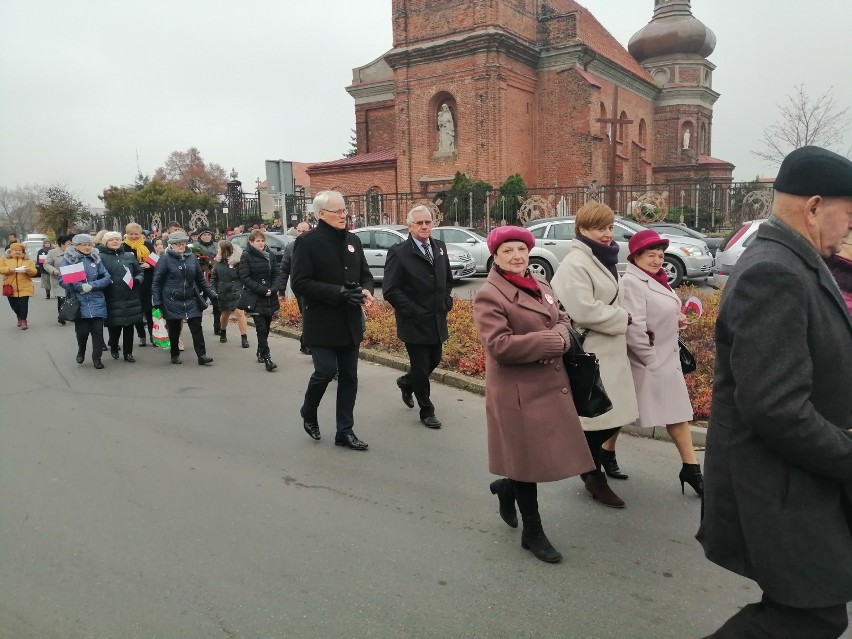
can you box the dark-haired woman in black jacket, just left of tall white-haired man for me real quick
[239,230,279,372]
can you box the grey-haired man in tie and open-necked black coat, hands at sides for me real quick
[382,206,453,428]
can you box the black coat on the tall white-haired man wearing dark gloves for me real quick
[290,220,373,347]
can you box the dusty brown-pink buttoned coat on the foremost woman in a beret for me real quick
[473,269,595,482]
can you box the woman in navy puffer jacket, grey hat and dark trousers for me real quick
[151,231,216,366]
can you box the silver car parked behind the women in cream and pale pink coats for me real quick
[525,215,713,287]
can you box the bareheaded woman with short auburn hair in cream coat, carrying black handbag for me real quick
[551,202,639,508]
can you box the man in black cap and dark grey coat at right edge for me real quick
[697,147,852,639]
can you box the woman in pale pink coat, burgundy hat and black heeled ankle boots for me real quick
[622,229,704,496]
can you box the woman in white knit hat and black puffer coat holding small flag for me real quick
[100,231,145,363]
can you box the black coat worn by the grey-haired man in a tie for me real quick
[382,235,453,344]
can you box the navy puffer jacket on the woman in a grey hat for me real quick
[151,247,216,319]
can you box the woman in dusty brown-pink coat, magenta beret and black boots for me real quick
[473,226,594,563]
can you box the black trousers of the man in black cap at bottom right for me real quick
[710,594,849,639]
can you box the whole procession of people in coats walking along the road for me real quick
[5,147,852,639]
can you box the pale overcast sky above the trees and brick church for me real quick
[0,0,852,206]
